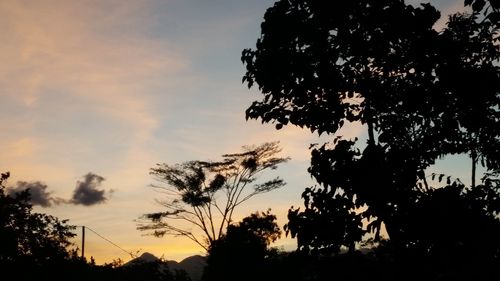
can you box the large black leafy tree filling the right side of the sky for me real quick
[242,0,500,252]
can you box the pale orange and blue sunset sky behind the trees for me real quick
[0,0,468,264]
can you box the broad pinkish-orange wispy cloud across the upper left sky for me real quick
[0,0,189,188]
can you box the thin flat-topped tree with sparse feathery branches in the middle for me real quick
[138,142,288,250]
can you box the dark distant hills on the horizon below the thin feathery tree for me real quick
[123,252,206,281]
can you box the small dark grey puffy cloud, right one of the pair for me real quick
[70,173,108,206]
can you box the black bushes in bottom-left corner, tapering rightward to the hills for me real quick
[0,173,190,281]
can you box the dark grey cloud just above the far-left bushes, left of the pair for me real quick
[7,181,55,207]
